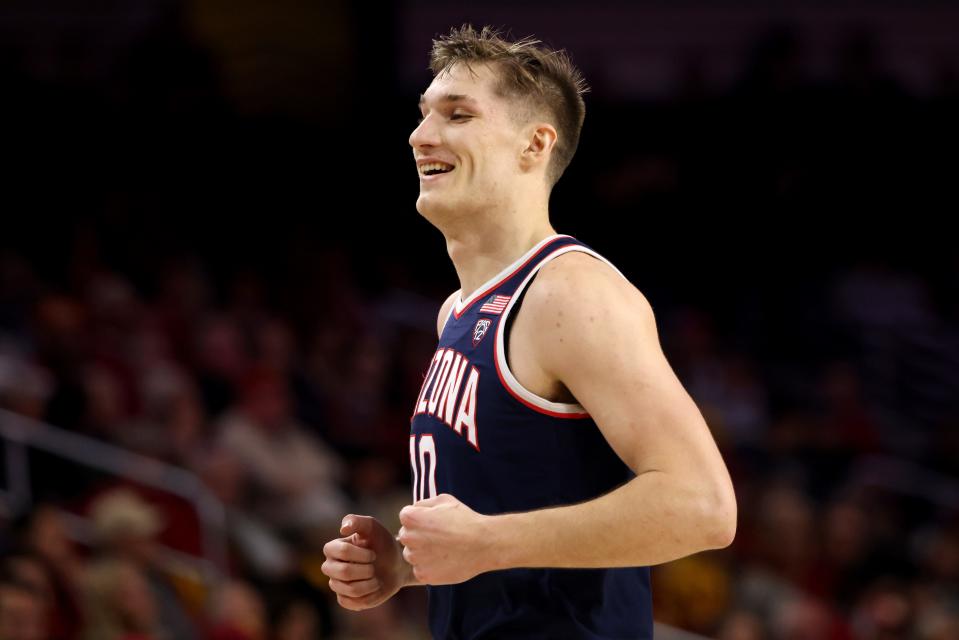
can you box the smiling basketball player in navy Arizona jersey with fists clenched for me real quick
[323,27,736,639]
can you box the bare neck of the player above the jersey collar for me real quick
[443,207,556,300]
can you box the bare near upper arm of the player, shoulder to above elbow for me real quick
[537,267,722,473]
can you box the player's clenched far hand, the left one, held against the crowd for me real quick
[321,514,413,611]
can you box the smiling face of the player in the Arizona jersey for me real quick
[410,64,528,220]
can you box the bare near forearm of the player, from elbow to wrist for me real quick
[487,471,736,569]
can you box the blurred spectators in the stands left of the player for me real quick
[0,254,428,640]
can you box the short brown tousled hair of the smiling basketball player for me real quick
[430,24,589,187]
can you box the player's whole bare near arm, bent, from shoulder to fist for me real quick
[400,253,736,582]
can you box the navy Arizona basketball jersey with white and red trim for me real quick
[410,235,653,640]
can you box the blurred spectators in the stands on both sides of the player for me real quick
[0,244,959,640]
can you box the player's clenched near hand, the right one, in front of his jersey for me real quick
[396,493,496,584]
